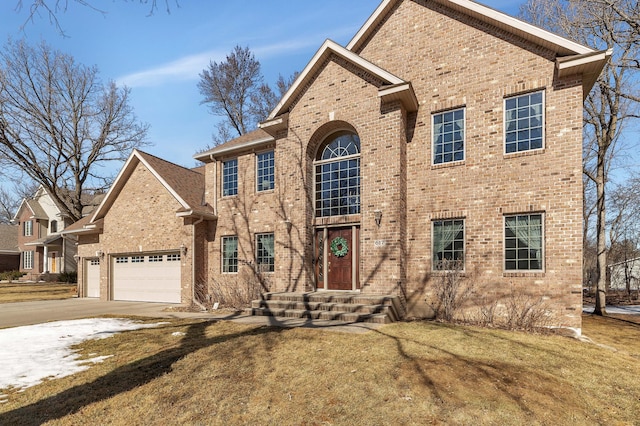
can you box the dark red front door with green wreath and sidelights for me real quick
[316,226,360,290]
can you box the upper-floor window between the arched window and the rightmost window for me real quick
[433,108,464,164]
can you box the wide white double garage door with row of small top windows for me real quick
[111,253,181,303]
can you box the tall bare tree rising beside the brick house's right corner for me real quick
[521,0,640,315]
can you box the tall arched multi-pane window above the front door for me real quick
[315,132,360,217]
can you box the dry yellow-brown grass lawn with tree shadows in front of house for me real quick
[0,316,640,425]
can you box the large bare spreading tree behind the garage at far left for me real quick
[0,41,148,220]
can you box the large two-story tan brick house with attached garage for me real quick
[72,0,610,329]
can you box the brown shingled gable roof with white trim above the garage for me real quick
[90,150,214,227]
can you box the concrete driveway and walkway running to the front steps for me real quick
[0,298,381,333]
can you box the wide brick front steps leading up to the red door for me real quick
[246,292,404,324]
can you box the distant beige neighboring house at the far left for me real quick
[12,186,102,280]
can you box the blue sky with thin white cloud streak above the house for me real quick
[0,0,523,172]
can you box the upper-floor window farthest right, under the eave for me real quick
[504,92,544,154]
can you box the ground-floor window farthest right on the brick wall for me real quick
[504,214,543,271]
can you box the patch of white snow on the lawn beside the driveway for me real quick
[0,318,165,396]
